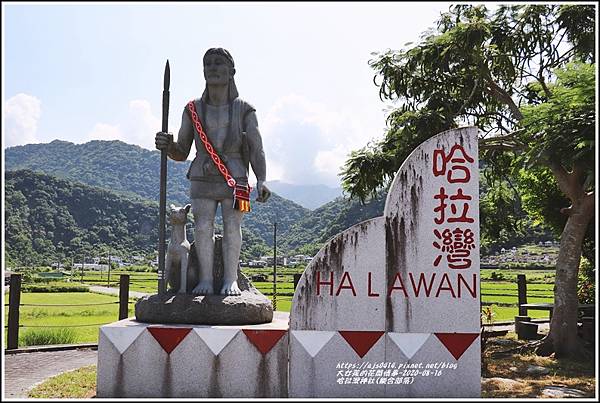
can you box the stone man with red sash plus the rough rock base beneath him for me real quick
[135,48,273,325]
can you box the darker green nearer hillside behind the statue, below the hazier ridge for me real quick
[5,170,269,265]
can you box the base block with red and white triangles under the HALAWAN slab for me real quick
[289,329,481,398]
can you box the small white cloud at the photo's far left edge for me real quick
[4,93,42,147]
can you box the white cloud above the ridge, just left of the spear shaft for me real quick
[86,99,160,150]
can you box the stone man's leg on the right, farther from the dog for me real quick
[221,199,244,295]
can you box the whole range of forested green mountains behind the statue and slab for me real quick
[5,140,385,266]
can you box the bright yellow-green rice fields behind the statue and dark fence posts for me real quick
[5,268,554,343]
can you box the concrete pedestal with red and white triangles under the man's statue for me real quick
[97,312,289,398]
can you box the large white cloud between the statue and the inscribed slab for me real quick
[259,94,384,186]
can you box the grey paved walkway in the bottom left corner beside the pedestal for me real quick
[4,349,98,399]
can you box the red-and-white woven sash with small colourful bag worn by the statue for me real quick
[187,101,252,213]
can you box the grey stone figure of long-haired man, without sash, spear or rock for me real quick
[155,48,271,295]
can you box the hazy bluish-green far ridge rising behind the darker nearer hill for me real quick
[5,140,310,246]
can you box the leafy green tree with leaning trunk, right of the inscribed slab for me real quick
[342,5,595,357]
